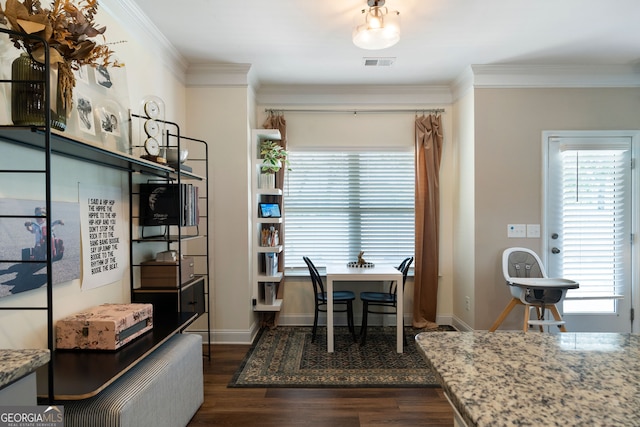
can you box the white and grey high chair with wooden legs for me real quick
[489,247,579,332]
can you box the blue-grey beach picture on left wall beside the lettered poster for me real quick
[0,199,80,297]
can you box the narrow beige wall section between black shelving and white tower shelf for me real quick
[187,84,253,342]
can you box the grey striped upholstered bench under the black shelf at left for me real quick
[63,334,204,427]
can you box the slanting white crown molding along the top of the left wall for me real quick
[100,0,188,83]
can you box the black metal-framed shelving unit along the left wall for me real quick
[0,28,211,404]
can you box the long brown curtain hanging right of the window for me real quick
[413,114,442,328]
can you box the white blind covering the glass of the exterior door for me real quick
[561,144,631,313]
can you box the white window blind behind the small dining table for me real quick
[284,151,415,268]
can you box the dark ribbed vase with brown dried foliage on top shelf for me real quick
[0,0,121,130]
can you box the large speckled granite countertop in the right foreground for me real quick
[416,331,640,426]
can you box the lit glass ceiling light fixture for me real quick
[353,0,400,50]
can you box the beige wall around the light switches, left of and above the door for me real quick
[470,87,640,329]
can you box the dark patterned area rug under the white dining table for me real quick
[228,326,455,388]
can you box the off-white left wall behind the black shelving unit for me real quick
[0,0,185,348]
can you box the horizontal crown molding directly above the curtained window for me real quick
[256,85,452,106]
